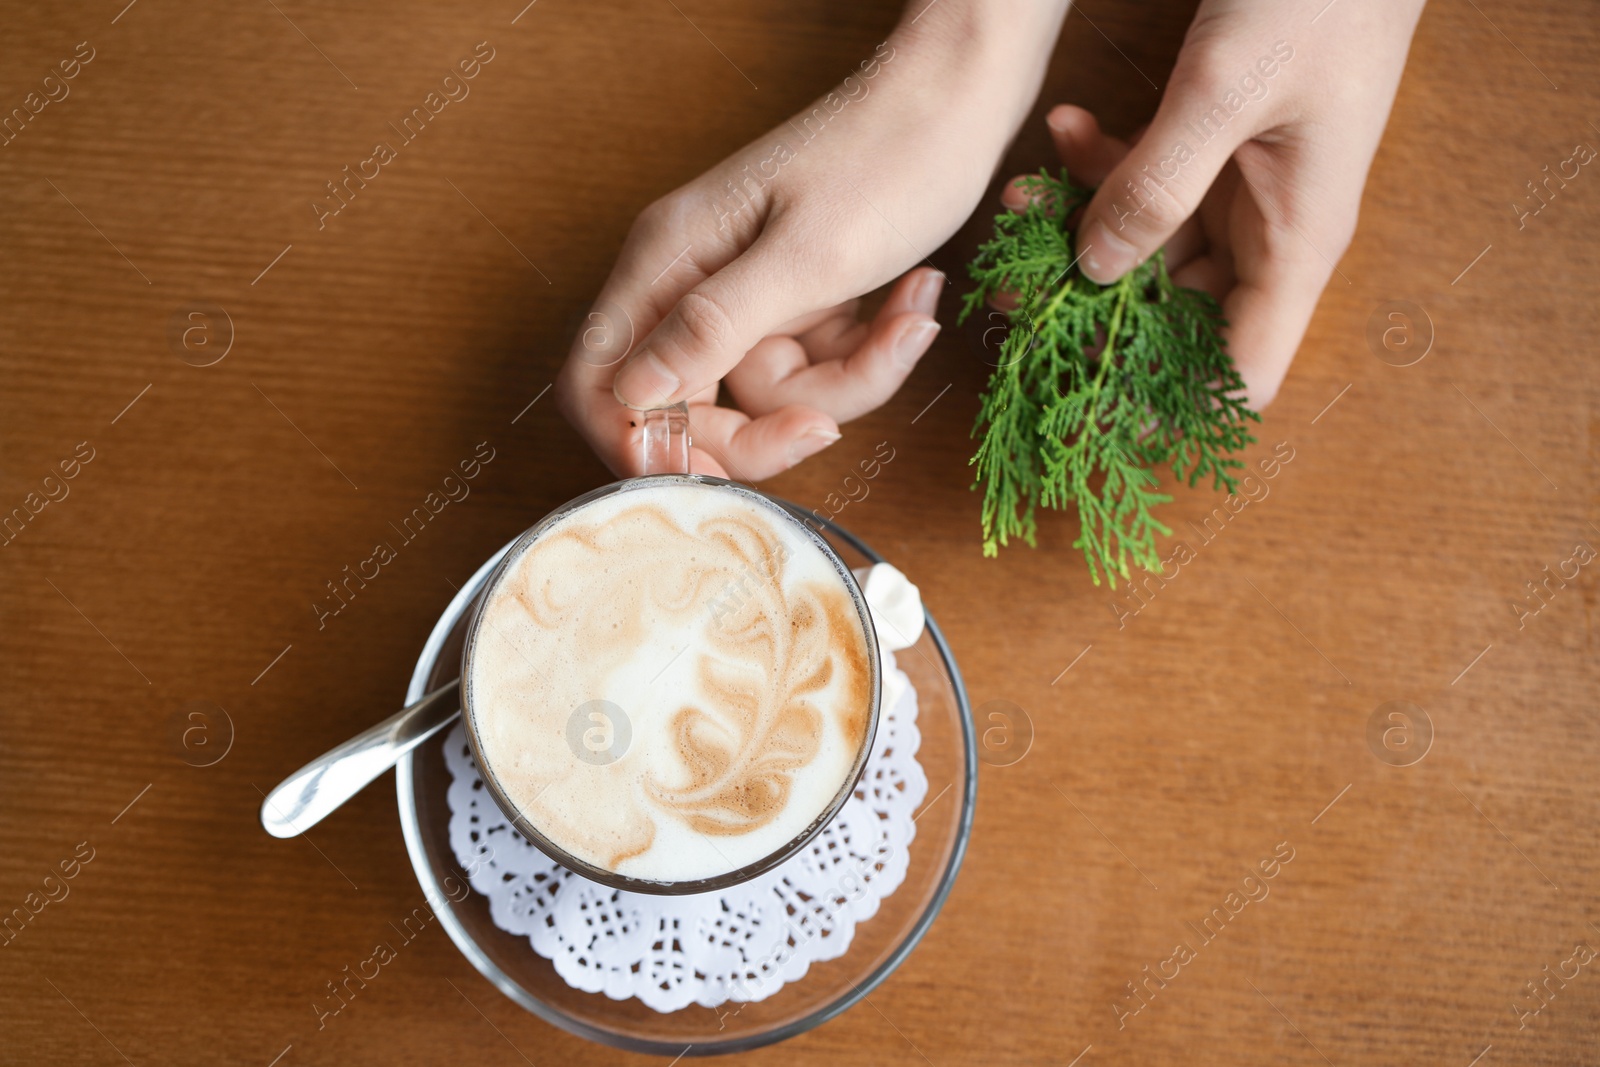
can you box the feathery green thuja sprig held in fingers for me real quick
[958,171,1259,589]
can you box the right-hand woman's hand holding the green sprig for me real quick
[1003,0,1422,408]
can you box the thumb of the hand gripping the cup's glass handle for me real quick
[611,240,806,408]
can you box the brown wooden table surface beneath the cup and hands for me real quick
[0,0,1600,1067]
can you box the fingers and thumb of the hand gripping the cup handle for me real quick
[555,199,944,480]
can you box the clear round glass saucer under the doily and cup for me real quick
[395,501,978,1056]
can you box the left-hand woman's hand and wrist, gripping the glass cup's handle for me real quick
[557,0,1066,482]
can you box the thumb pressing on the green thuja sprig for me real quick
[1078,82,1253,285]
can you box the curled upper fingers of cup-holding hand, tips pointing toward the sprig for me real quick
[726,267,944,422]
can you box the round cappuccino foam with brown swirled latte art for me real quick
[467,482,872,883]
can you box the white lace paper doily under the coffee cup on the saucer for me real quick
[445,649,928,1011]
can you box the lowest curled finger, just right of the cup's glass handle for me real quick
[690,405,838,482]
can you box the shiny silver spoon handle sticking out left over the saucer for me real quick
[261,678,461,837]
